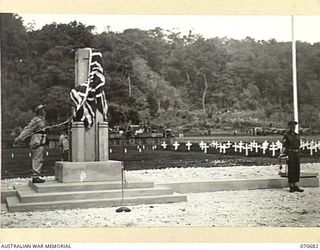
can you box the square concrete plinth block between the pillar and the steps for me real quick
[55,160,122,183]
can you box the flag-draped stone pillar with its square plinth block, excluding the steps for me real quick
[55,48,121,182]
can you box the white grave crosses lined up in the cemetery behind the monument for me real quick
[109,140,320,156]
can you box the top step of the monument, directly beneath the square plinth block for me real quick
[23,179,154,193]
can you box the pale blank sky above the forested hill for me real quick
[19,14,320,43]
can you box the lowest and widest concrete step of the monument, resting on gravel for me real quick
[6,193,187,212]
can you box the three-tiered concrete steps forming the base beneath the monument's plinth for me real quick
[5,178,187,212]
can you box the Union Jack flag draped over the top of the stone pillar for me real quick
[70,49,108,127]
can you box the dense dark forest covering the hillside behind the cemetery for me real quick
[1,14,320,134]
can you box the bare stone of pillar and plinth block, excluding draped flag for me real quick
[55,48,121,182]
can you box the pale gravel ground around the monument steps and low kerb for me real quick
[1,163,320,228]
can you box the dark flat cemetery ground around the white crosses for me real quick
[1,136,320,179]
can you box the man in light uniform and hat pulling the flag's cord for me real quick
[14,104,47,183]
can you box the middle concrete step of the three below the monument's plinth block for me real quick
[17,186,173,203]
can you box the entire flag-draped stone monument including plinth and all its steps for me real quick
[4,48,187,212]
